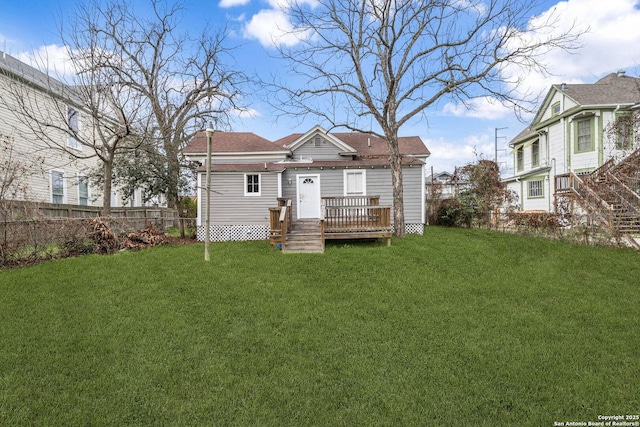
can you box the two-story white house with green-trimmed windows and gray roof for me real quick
[504,71,640,212]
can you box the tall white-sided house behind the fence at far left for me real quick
[0,52,142,211]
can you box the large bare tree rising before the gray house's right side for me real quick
[273,0,580,236]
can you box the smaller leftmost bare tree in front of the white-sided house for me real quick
[0,50,131,215]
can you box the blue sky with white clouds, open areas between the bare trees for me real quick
[0,0,640,176]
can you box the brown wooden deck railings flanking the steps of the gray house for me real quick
[269,196,391,251]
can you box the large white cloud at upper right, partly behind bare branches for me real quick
[443,0,640,126]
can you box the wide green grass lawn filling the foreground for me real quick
[0,228,640,426]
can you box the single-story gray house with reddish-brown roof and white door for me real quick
[183,126,429,246]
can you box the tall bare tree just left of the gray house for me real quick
[73,0,244,207]
